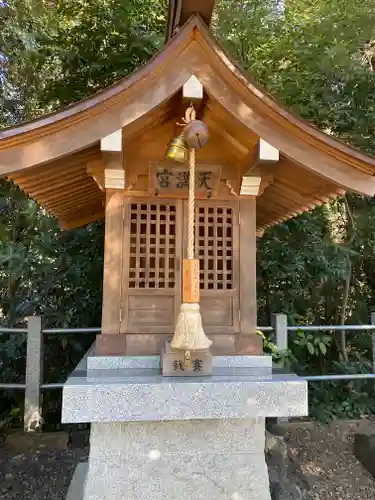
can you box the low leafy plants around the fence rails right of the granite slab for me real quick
[258,330,375,422]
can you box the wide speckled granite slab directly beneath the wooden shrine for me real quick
[62,356,307,423]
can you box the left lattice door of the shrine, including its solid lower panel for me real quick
[122,199,181,333]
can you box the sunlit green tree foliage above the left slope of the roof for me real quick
[0,0,165,124]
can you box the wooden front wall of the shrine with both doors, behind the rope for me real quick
[98,165,262,355]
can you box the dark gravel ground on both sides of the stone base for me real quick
[0,422,375,500]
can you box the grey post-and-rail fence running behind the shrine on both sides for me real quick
[0,313,375,432]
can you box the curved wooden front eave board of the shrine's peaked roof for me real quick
[0,15,375,195]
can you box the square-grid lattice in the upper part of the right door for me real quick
[195,206,234,290]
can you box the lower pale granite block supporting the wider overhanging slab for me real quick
[84,418,271,500]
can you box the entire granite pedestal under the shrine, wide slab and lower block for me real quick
[63,356,307,500]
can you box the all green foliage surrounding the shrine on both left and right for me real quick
[0,0,375,421]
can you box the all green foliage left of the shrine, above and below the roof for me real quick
[0,0,166,421]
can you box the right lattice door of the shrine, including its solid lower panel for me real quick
[185,200,239,333]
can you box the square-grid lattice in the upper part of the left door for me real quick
[129,203,176,290]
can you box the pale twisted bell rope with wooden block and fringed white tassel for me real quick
[171,119,212,354]
